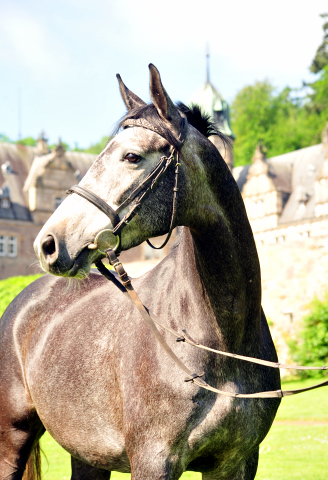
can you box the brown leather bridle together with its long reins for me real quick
[66,119,328,398]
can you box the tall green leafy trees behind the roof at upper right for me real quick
[231,14,328,165]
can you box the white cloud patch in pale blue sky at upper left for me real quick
[0,10,69,81]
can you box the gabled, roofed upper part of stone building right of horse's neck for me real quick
[233,125,328,245]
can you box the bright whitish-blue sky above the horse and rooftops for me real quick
[0,0,328,148]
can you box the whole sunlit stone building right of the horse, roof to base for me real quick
[233,125,328,362]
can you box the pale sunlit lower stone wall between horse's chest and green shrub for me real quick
[257,239,328,362]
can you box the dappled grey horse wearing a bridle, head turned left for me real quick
[0,64,280,480]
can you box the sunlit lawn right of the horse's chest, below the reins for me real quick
[256,379,328,480]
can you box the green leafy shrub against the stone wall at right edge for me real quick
[289,293,328,377]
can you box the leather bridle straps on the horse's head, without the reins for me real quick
[66,118,186,255]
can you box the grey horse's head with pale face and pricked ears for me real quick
[34,64,227,278]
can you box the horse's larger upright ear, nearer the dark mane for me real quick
[149,63,181,129]
